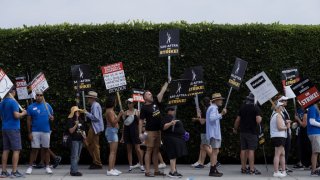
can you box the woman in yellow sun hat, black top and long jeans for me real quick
[67,106,86,176]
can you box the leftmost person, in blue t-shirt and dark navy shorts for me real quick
[0,87,27,177]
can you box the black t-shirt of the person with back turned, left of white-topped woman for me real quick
[238,103,261,134]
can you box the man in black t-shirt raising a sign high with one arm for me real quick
[139,82,168,177]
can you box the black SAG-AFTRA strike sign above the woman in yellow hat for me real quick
[71,64,91,91]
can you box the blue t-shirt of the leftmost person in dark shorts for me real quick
[0,98,20,130]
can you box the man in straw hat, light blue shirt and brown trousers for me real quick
[84,91,104,169]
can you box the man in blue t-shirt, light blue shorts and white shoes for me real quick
[26,91,54,174]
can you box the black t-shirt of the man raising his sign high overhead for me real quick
[140,98,161,131]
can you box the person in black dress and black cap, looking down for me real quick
[161,106,188,178]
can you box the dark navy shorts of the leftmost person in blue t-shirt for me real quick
[2,129,22,151]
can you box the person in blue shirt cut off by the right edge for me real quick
[307,104,320,176]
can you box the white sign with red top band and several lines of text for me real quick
[101,62,127,93]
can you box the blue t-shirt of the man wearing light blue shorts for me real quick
[27,102,53,132]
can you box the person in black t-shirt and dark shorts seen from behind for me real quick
[233,93,262,175]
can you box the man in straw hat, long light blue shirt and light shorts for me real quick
[206,93,227,177]
